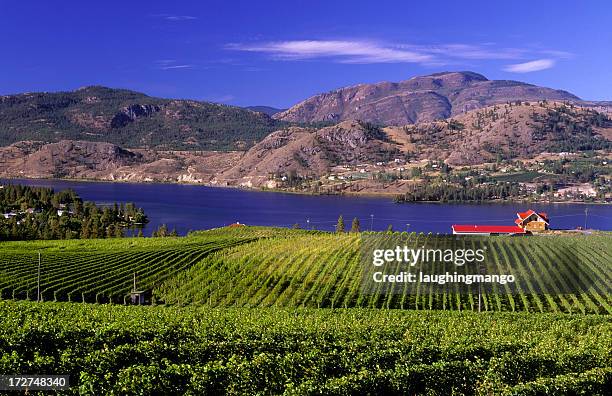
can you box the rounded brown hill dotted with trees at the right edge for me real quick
[396,101,612,165]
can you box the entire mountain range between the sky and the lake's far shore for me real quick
[0,72,612,187]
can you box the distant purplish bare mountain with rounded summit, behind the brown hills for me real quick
[274,72,580,125]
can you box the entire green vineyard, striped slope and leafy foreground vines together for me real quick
[0,227,612,395]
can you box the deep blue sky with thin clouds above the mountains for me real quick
[0,0,612,107]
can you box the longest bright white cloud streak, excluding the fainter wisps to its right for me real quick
[227,40,432,63]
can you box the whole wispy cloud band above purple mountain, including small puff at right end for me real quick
[225,40,573,73]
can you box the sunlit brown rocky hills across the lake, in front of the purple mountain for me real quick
[213,102,612,186]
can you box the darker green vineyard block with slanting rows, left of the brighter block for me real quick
[0,229,266,303]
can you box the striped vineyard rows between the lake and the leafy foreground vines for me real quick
[0,227,612,313]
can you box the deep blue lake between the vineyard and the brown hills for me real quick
[2,179,612,235]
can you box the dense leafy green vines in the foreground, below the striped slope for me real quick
[0,301,612,395]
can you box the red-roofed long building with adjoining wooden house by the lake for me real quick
[451,209,549,235]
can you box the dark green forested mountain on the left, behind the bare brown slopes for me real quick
[0,86,282,150]
